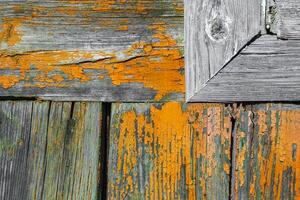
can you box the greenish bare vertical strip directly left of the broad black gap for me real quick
[62,102,102,199]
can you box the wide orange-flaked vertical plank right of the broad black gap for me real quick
[108,102,231,199]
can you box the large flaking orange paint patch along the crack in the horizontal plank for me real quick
[0,23,184,100]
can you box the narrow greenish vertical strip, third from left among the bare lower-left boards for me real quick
[41,102,72,199]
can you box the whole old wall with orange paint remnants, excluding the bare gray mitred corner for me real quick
[0,0,300,199]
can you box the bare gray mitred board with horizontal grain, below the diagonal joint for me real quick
[190,35,300,102]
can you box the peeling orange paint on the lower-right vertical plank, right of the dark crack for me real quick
[253,110,300,199]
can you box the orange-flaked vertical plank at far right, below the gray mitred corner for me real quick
[232,104,300,199]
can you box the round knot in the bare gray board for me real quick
[206,17,229,42]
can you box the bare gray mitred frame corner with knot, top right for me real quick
[185,0,300,102]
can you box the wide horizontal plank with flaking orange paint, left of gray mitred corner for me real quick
[0,0,184,101]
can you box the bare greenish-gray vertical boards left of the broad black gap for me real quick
[0,101,102,199]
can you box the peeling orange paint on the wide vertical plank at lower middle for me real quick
[109,102,230,199]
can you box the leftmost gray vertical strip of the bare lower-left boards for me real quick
[0,101,32,200]
